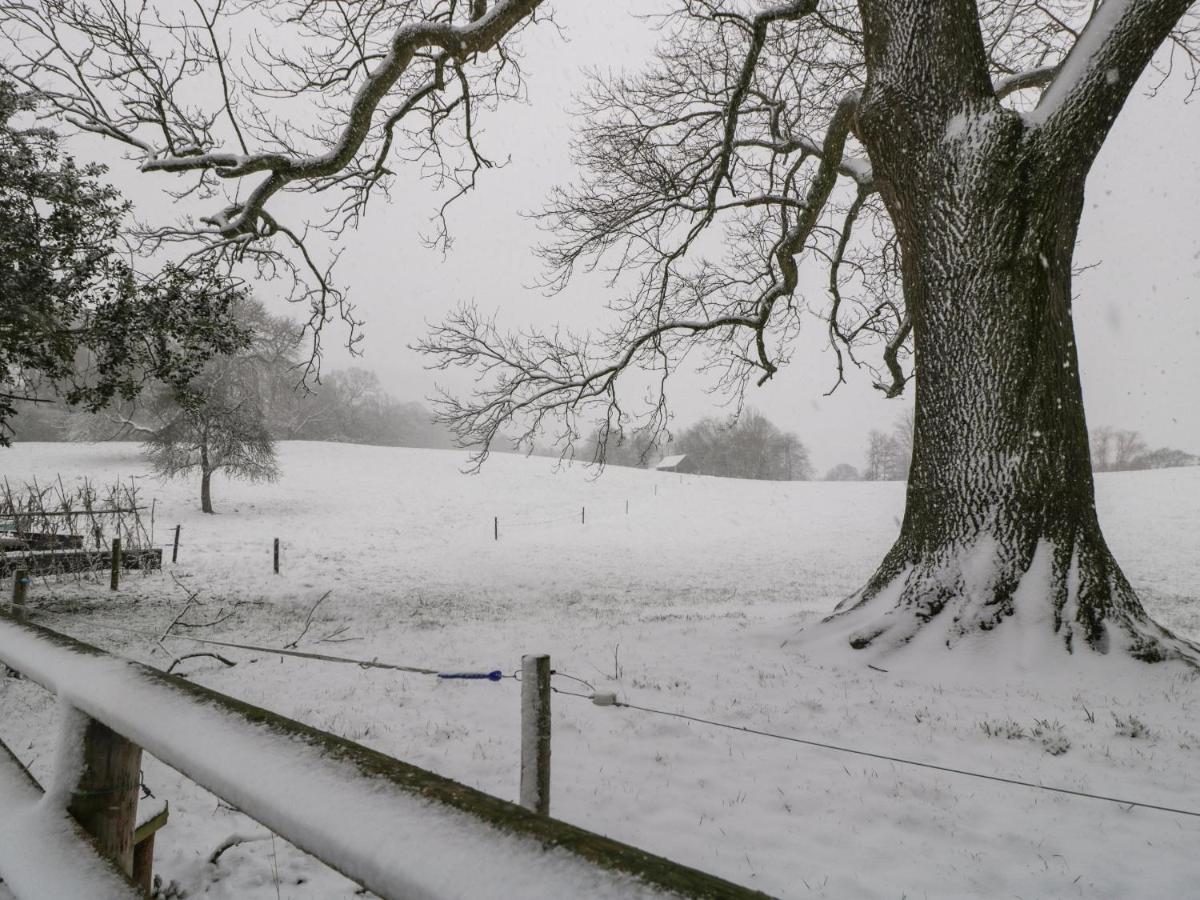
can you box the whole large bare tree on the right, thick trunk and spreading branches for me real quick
[426,0,1196,661]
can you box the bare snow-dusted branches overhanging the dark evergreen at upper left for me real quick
[0,0,549,369]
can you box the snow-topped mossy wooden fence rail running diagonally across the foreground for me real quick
[0,612,764,900]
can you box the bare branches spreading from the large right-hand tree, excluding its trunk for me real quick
[422,0,1198,465]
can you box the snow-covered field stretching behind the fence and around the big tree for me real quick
[0,444,1200,900]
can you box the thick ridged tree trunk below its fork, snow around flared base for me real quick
[832,28,1195,660]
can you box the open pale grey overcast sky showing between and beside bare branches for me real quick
[105,0,1200,473]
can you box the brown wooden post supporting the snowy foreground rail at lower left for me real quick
[67,713,142,875]
